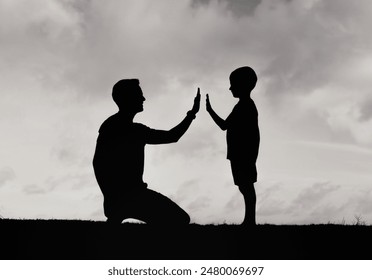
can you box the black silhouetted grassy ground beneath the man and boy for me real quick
[0,219,372,260]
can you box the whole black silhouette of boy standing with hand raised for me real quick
[206,66,260,226]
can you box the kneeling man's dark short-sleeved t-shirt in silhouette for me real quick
[93,113,157,196]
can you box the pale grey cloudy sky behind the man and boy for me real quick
[0,0,372,224]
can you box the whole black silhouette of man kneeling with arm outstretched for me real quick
[93,79,200,225]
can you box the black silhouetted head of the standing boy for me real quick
[230,66,257,98]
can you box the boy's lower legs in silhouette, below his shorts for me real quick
[239,183,257,226]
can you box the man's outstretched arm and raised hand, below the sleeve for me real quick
[147,88,200,144]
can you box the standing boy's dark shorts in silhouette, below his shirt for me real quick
[230,159,257,186]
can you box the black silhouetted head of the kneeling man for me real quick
[112,79,146,113]
